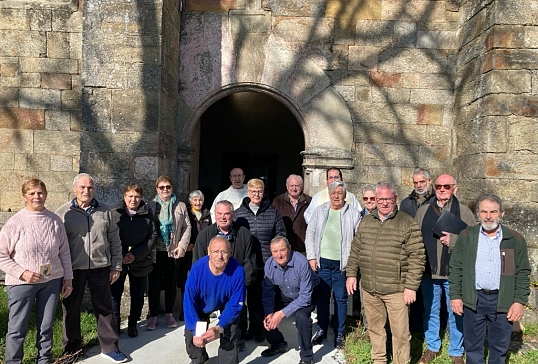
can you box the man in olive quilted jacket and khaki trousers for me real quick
[346,182,425,364]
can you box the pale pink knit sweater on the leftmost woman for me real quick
[0,209,73,286]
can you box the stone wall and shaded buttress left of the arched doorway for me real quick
[0,0,180,211]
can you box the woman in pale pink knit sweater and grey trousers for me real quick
[0,179,73,364]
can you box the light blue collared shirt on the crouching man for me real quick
[262,250,319,317]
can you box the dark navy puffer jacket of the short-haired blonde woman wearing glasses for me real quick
[235,196,286,268]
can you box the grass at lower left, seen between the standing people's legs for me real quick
[0,287,98,364]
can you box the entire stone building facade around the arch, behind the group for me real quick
[0,0,538,305]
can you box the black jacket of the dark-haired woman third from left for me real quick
[113,201,157,277]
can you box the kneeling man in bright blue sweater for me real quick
[183,236,245,364]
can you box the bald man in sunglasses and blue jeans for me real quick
[415,174,475,364]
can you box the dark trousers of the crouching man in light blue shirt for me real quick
[256,289,317,361]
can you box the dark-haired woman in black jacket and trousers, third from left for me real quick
[110,184,157,337]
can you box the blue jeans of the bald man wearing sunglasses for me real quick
[420,278,463,356]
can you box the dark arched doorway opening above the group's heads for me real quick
[198,91,305,206]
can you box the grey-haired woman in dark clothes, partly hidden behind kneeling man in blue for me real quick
[177,190,212,321]
